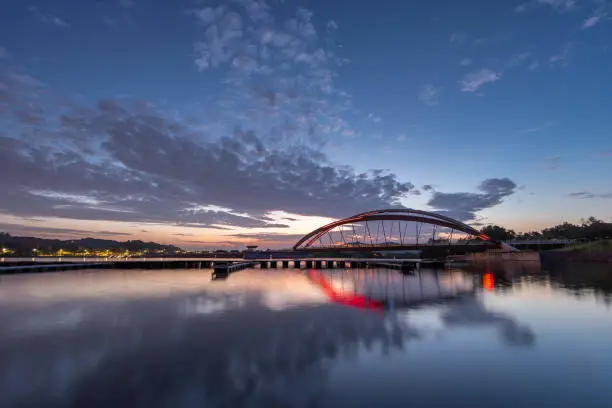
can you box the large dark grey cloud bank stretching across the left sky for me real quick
[0,65,413,228]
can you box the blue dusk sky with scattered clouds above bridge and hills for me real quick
[0,0,612,248]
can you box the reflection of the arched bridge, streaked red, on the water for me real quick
[307,269,476,309]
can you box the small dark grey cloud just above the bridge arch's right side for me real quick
[423,178,517,221]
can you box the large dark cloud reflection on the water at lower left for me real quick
[0,286,420,407]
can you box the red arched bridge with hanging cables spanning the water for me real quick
[293,208,502,257]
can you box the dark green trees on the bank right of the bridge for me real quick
[480,217,612,241]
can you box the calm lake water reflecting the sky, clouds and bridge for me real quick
[0,263,612,408]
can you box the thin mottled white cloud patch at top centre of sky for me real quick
[191,0,357,145]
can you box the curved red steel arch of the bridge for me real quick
[293,208,496,250]
